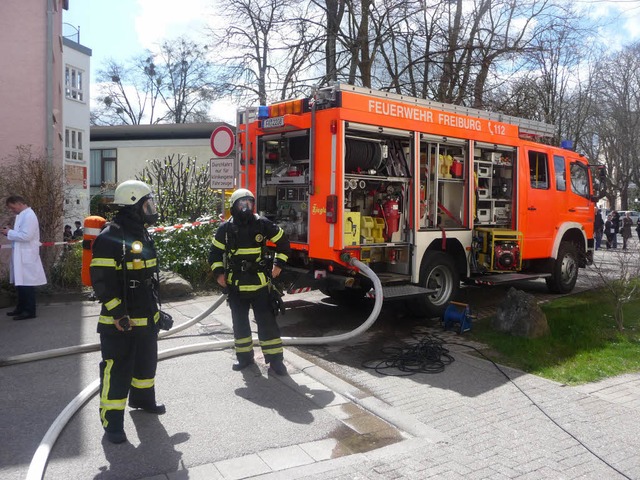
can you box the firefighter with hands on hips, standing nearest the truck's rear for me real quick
[209,188,289,375]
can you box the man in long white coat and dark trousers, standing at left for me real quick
[2,195,47,320]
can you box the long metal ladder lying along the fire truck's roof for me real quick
[320,83,555,137]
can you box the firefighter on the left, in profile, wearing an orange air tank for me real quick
[90,180,166,443]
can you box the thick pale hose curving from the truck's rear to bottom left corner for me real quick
[26,257,383,480]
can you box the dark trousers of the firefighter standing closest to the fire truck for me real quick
[228,287,283,363]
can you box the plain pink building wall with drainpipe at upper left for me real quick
[0,0,67,165]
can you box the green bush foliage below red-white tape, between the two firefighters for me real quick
[153,222,219,290]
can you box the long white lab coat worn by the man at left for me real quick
[7,207,47,286]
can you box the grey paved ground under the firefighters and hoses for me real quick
[0,248,640,480]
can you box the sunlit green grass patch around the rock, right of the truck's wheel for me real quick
[470,290,640,385]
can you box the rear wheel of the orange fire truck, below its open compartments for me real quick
[407,251,460,317]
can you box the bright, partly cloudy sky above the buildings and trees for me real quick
[63,0,640,123]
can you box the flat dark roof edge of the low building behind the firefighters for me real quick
[90,122,235,142]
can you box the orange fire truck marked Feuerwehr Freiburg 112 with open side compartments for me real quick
[236,84,604,316]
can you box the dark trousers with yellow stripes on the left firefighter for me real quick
[100,333,158,432]
